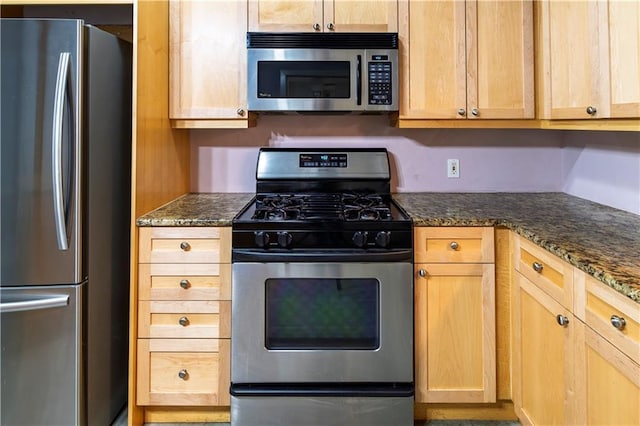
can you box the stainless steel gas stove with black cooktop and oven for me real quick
[231,148,413,426]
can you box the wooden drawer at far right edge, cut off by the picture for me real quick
[575,271,640,363]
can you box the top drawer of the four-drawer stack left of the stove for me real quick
[139,227,231,263]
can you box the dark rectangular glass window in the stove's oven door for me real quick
[265,278,380,350]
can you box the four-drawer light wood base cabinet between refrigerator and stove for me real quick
[136,227,231,406]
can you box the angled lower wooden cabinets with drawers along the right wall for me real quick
[512,236,640,425]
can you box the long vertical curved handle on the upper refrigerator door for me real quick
[51,52,71,250]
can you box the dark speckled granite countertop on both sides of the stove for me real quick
[136,192,640,303]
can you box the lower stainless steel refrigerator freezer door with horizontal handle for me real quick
[0,284,86,426]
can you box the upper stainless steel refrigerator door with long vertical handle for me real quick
[0,19,85,287]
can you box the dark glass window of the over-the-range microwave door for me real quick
[258,61,350,99]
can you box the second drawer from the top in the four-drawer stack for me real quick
[138,263,231,300]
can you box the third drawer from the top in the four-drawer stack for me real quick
[138,300,231,339]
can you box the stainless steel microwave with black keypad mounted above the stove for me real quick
[247,32,398,113]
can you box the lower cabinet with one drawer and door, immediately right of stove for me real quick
[414,227,496,403]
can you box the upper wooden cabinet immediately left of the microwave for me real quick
[169,0,249,128]
